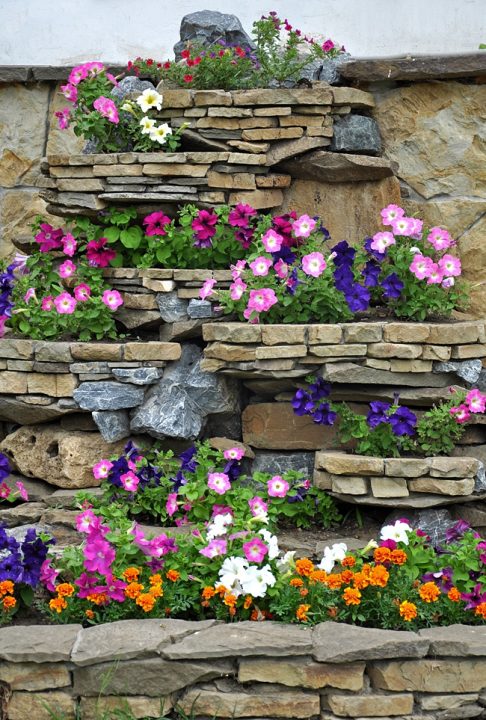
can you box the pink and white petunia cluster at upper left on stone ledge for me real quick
[55,62,185,152]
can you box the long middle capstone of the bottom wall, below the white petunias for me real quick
[160,622,312,660]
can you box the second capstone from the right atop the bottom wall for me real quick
[312,622,429,662]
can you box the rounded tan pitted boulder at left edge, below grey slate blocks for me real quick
[0,425,128,488]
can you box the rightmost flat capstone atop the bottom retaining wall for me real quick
[418,625,486,657]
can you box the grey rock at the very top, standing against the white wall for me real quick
[174,10,255,60]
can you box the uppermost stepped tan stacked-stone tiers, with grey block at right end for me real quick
[42,82,393,215]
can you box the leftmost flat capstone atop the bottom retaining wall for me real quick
[0,625,81,663]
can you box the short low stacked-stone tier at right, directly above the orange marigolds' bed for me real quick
[314,451,486,508]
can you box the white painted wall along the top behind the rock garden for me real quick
[0,0,486,65]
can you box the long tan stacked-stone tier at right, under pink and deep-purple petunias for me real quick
[203,320,486,388]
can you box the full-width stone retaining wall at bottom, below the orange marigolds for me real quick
[0,619,486,720]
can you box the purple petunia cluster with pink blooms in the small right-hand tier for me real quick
[292,377,486,457]
